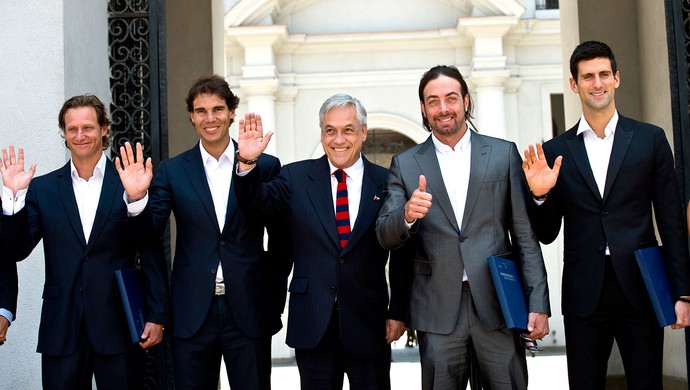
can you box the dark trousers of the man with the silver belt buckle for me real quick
[172,295,271,390]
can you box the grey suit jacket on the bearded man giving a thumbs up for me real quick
[376,132,550,334]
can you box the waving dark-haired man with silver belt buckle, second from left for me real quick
[120,76,290,390]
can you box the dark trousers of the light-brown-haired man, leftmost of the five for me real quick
[41,327,145,390]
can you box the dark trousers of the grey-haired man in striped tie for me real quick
[295,309,391,390]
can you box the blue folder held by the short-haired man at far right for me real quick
[635,246,676,328]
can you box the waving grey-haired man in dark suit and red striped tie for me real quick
[234,94,405,389]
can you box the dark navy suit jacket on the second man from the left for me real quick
[149,141,289,338]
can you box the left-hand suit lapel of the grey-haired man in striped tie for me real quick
[306,155,340,248]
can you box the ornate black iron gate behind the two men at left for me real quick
[108,0,169,389]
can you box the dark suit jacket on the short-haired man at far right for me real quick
[532,115,690,317]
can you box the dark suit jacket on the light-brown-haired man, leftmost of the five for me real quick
[2,161,167,355]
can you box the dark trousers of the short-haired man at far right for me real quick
[564,256,664,390]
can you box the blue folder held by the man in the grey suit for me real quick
[487,256,528,330]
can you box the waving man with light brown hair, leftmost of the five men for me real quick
[0,95,167,389]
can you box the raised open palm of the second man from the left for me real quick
[115,142,153,201]
